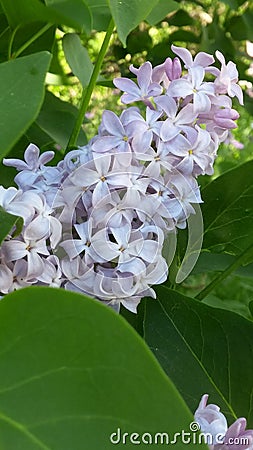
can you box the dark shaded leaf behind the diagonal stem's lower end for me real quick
[36,92,87,149]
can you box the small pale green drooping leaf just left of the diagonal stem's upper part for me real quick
[62,33,93,87]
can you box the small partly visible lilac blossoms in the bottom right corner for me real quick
[194,394,253,450]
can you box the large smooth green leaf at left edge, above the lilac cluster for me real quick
[0,52,51,158]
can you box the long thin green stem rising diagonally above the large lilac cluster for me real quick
[67,19,114,150]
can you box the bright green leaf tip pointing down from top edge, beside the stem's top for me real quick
[108,0,158,46]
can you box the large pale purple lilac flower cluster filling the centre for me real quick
[0,46,243,311]
